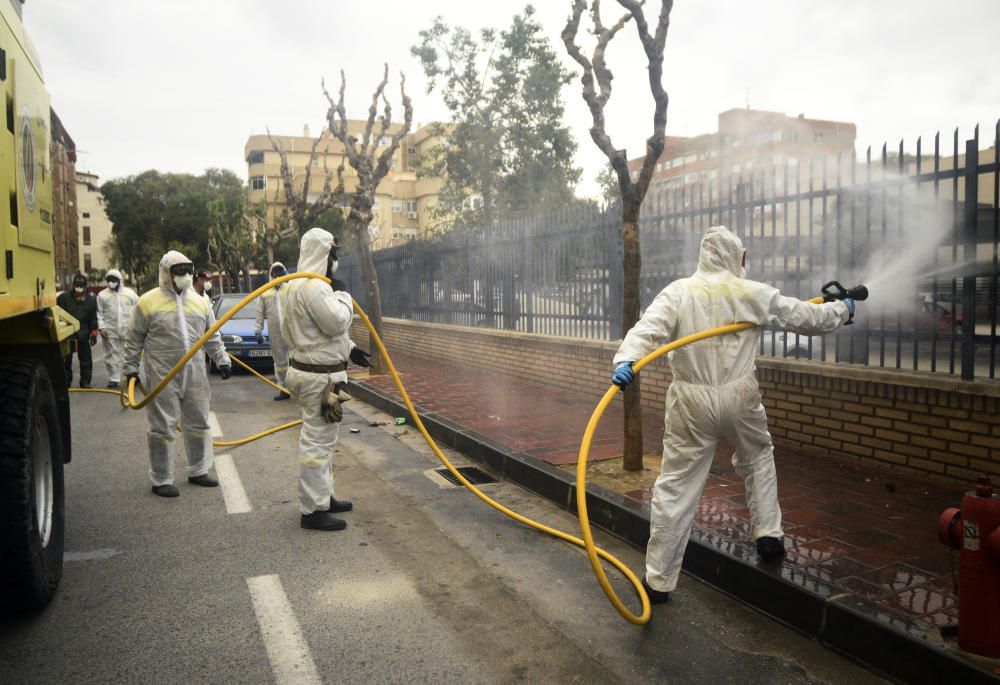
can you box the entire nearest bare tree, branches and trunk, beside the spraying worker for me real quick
[562,0,674,471]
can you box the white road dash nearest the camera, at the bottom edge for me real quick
[247,576,322,685]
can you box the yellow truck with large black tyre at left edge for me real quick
[0,0,79,610]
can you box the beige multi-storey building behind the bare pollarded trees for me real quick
[244,120,441,249]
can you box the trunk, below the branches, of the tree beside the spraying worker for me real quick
[622,207,642,471]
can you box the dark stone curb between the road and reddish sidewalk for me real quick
[350,380,1000,685]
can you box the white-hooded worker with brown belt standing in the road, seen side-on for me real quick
[278,228,371,530]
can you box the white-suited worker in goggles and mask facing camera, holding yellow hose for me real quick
[123,250,232,497]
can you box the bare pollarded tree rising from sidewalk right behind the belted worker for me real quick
[323,64,413,373]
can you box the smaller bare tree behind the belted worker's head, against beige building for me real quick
[265,129,344,262]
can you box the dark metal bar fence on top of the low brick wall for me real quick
[341,122,1000,380]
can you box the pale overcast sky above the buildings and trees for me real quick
[21,0,1000,194]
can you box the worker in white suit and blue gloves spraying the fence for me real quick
[612,226,854,604]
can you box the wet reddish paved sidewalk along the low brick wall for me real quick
[350,353,1000,682]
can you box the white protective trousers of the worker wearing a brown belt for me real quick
[285,369,347,514]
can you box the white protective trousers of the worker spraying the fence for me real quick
[646,376,783,592]
